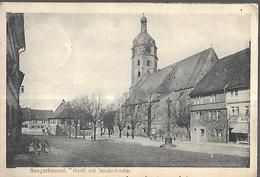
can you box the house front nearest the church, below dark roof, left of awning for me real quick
[190,93,227,143]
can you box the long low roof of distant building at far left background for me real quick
[21,108,53,121]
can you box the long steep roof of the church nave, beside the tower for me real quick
[134,48,217,97]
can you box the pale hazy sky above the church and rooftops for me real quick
[20,13,250,110]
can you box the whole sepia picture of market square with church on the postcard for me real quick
[2,1,257,176]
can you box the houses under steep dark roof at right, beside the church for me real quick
[190,48,250,143]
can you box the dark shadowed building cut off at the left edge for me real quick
[6,13,25,167]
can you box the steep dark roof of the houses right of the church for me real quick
[190,48,250,97]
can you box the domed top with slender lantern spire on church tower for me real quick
[133,16,155,47]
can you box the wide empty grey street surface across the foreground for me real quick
[16,136,249,167]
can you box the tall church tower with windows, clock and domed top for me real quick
[132,16,158,87]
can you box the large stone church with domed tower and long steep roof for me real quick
[129,16,218,139]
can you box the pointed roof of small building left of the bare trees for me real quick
[51,100,72,119]
